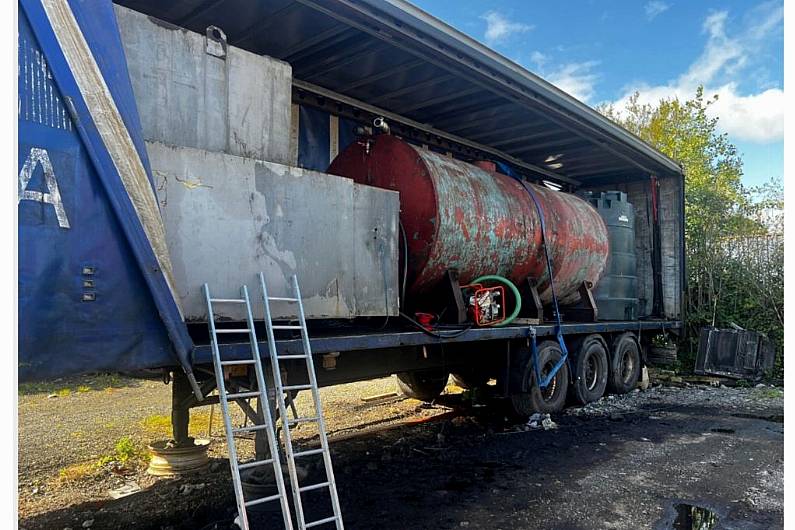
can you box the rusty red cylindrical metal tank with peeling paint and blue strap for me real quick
[328,134,609,304]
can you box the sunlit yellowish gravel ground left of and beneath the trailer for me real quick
[17,375,454,521]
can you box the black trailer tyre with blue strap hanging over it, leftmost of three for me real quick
[511,340,569,416]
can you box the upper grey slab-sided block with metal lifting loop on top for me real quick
[114,5,292,164]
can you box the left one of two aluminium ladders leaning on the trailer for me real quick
[204,283,293,530]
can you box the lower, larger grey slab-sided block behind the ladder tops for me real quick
[147,142,400,321]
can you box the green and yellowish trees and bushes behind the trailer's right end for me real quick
[599,88,784,374]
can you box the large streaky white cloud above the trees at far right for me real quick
[614,3,785,143]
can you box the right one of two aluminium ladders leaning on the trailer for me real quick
[259,272,344,530]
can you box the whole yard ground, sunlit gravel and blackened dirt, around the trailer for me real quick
[18,376,784,530]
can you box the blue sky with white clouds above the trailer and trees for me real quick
[411,0,785,185]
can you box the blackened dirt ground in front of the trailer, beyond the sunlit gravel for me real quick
[20,387,784,530]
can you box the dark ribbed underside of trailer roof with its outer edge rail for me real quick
[112,0,682,186]
